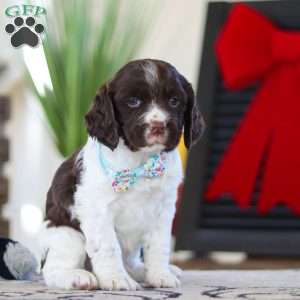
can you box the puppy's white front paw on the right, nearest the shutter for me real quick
[145,269,180,288]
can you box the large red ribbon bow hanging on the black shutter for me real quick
[205,4,300,214]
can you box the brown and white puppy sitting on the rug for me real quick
[41,59,204,290]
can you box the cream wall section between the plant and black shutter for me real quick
[138,0,207,85]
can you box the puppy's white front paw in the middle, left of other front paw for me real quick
[97,272,141,291]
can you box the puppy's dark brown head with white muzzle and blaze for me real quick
[86,59,204,151]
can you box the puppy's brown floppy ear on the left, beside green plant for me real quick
[85,85,119,150]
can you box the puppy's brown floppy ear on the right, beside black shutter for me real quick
[181,76,205,148]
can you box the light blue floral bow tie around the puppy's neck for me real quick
[97,143,166,192]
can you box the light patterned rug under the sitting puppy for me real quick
[0,270,300,300]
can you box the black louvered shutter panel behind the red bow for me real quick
[176,0,300,256]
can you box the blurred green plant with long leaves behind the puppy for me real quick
[27,0,154,157]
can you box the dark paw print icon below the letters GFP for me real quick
[5,17,45,48]
